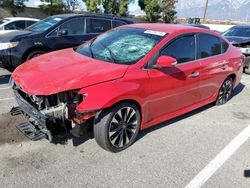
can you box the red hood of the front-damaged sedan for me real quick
[12,49,128,95]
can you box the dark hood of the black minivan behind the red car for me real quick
[0,30,35,42]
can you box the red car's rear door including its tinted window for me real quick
[198,33,229,100]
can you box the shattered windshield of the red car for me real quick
[76,28,167,65]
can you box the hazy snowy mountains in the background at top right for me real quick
[176,0,250,21]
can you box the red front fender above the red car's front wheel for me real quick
[76,80,146,112]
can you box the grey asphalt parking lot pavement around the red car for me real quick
[0,70,250,188]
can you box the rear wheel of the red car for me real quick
[216,77,234,105]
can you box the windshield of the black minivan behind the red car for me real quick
[26,16,63,32]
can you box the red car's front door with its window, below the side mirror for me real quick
[148,34,200,119]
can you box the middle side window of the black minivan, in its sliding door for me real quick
[87,18,111,33]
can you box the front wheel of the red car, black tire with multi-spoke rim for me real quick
[94,102,141,153]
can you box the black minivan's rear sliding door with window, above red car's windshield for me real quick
[86,18,111,40]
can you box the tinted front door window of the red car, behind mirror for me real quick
[160,35,196,64]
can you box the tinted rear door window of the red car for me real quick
[199,34,222,59]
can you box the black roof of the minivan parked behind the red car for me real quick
[51,13,133,23]
